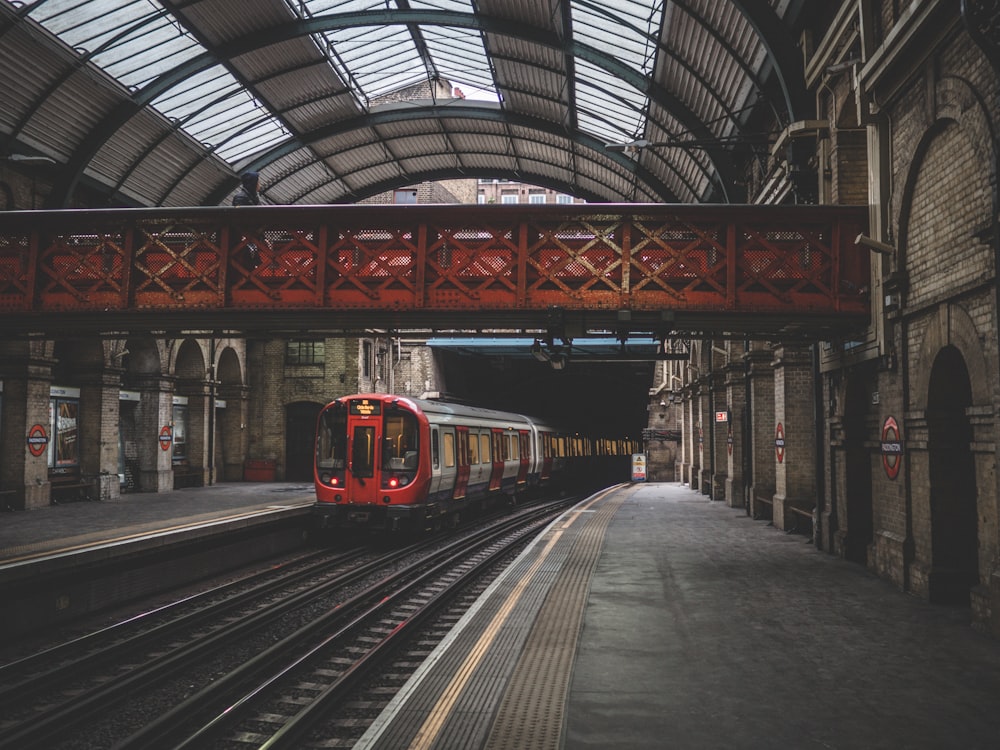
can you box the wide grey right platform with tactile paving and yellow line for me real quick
[355,484,1000,750]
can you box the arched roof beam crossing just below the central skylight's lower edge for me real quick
[205,104,687,205]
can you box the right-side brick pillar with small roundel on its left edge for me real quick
[773,345,816,529]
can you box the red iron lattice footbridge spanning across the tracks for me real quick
[0,204,870,339]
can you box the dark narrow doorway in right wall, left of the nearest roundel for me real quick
[844,377,875,565]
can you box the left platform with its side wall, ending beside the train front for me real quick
[0,482,315,641]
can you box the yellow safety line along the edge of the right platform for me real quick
[410,487,618,750]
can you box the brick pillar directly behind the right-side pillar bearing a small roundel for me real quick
[746,343,776,518]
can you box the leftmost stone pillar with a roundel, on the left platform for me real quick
[0,344,54,510]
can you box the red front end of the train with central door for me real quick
[313,394,430,531]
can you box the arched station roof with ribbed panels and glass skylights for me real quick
[0,0,829,206]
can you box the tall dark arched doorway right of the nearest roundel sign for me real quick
[927,346,979,606]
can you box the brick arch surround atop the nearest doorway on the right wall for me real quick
[910,304,997,411]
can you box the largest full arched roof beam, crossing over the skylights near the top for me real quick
[50,10,735,207]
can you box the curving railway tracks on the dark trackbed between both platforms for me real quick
[0,496,565,748]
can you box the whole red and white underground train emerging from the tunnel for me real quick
[313,393,636,531]
